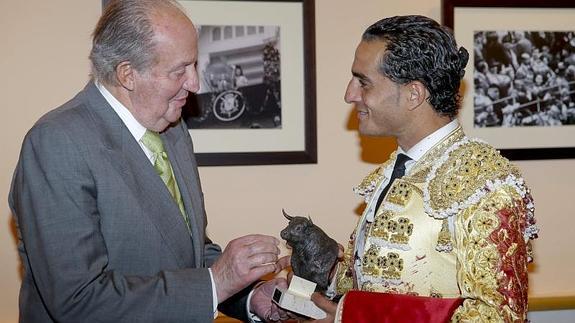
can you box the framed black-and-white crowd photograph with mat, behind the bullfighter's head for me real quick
[442,0,575,160]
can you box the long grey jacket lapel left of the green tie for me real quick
[80,83,198,267]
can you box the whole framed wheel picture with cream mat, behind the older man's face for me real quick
[102,0,317,166]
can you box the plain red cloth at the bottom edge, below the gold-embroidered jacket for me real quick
[342,291,463,323]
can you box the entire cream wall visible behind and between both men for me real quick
[0,0,575,322]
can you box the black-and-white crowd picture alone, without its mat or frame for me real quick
[473,30,575,127]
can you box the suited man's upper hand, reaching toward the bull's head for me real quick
[211,234,280,303]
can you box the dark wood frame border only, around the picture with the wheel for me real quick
[102,0,317,166]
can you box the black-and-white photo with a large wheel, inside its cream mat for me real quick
[185,25,282,129]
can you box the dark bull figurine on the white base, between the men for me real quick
[280,209,339,292]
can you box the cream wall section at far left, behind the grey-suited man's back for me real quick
[0,0,100,322]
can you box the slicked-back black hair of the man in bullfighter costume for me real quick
[362,16,469,118]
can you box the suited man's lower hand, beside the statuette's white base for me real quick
[250,278,291,322]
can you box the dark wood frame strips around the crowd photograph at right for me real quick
[441,0,575,160]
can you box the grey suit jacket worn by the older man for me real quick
[9,82,245,322]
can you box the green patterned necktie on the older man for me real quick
[140,130,191,232]
